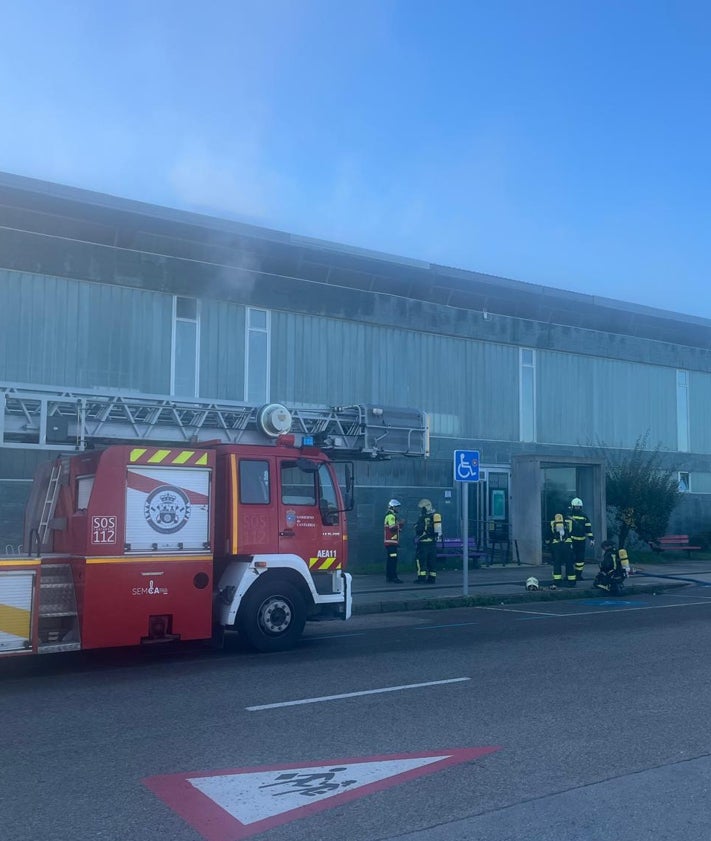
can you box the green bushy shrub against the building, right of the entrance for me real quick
[606,433,682,548]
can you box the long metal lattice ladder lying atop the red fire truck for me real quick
[0,383,429,459]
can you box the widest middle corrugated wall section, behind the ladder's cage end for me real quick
[271,312,518,441]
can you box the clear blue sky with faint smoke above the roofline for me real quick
[0,0,711,318]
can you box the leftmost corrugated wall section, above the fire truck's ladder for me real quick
[0,270,172,394]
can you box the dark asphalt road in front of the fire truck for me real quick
[0,586,711,841]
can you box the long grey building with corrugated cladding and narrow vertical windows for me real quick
[0,174,711,570]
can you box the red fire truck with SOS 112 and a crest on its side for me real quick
[0,404,428,655]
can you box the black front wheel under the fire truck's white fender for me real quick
[236,576,306,651]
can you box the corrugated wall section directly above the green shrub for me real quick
[536,351,680,450]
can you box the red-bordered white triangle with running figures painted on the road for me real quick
[143,747,500,841]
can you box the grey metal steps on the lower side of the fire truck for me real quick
[37,563,81,654]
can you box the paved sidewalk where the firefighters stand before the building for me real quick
[353,559,711,615]
